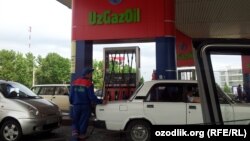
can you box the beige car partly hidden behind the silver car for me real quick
[31,84,70,112]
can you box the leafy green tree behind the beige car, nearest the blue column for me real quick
[35,53,70,84]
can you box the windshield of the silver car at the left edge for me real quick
[2,82,41,99]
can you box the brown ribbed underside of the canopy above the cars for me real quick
[57,0,250,39]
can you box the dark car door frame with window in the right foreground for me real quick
[193,39,250,124]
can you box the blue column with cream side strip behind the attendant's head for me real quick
[71,41,93,82]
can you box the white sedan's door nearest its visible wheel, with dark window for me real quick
[143,83,186,125]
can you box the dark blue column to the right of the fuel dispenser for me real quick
[156,37,177,79]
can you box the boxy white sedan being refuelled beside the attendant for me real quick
[96,80,250,141]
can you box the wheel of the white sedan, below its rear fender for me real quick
[126,120,151,141]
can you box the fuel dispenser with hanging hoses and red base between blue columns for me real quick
[103,47,140,101]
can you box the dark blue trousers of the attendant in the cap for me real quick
[71,105,91,138]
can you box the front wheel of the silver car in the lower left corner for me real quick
[0,119,22,141]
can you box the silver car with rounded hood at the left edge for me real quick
[0,80,62,141]
